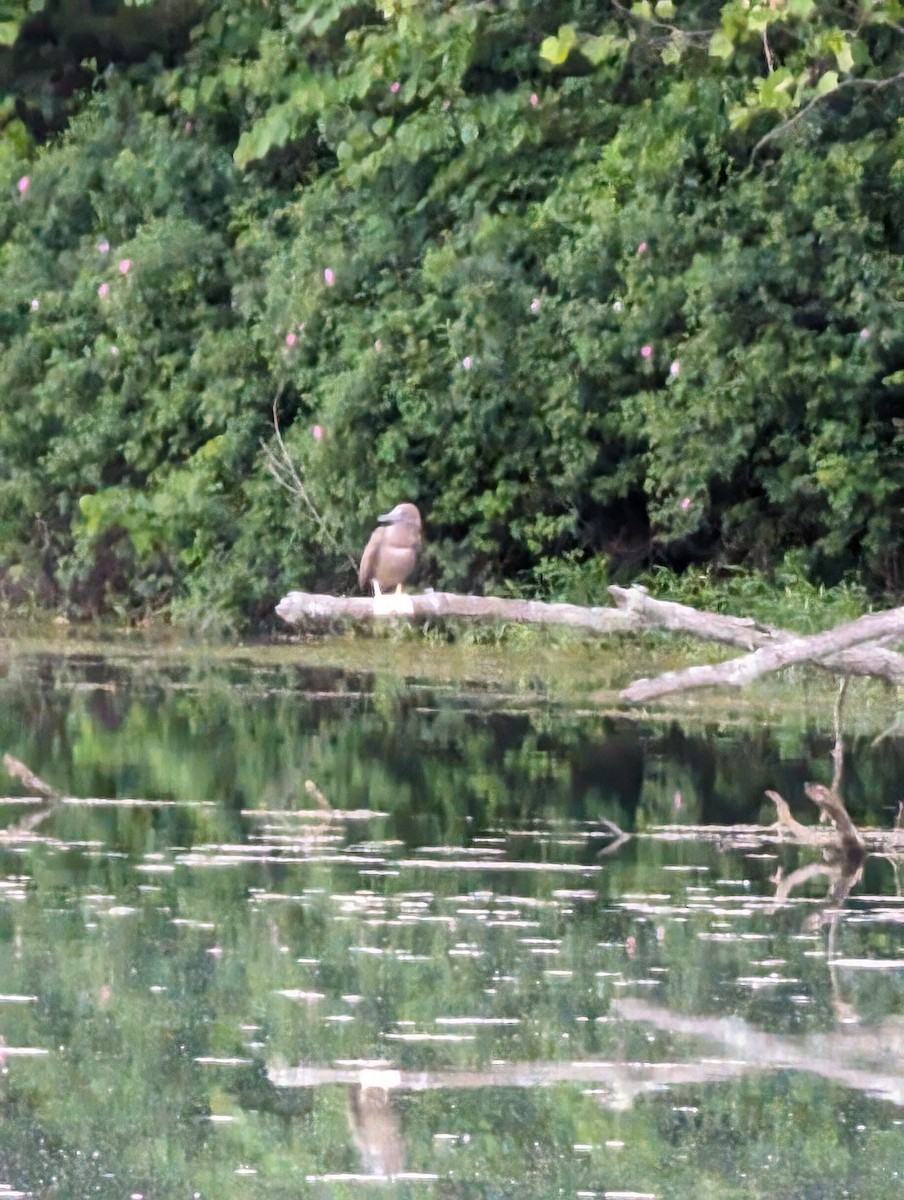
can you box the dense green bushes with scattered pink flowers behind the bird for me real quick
[0,0,904,622]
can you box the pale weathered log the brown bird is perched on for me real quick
[276,592,642,634]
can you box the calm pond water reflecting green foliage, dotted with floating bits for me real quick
[0,652,904,1200]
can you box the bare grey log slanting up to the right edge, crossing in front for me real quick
[619,608,904,704]
